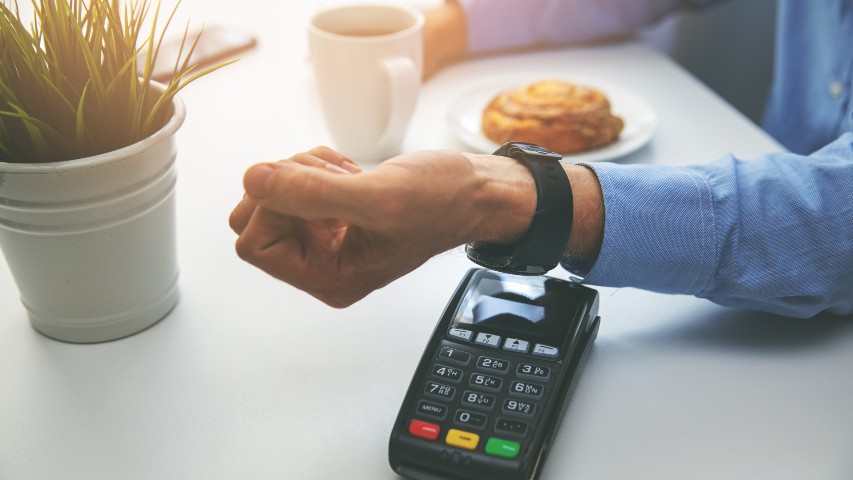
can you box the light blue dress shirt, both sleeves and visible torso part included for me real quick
[459,0,853,317]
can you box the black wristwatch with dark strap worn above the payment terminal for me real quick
[465,142,573,275]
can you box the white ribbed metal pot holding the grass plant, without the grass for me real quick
[0,94,186,343]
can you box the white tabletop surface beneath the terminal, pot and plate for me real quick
[0,0,853,480]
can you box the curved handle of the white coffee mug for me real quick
[377,55,421,154]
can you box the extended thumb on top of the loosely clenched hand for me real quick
[243,162,372,223]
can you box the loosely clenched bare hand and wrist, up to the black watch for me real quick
[230,147,536,308]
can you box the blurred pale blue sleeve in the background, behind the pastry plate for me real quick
[456,0,715,53]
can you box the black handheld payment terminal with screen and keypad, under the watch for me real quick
[389,269,599,480]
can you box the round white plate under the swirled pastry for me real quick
[447,73,658,162]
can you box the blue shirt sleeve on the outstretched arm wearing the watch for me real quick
[585,133,853,317]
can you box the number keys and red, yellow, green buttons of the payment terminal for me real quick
[410,329,556,459]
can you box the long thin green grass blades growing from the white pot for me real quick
[0,0,231,163]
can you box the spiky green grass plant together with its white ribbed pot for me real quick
[0,0,230,343]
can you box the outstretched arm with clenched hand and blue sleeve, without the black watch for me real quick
[231,133,853,317]
